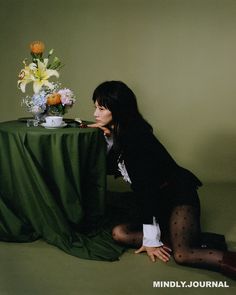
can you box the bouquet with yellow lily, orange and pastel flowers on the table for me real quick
[17,41,76,120]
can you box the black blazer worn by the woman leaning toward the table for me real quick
[108,125,201,223]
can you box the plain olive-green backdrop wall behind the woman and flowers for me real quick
[0,0,236,182]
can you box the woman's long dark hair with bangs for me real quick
[92,81,152,150]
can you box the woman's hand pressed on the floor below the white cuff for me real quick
[135,246,171,262]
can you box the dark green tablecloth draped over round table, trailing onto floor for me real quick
[0,121,123,261]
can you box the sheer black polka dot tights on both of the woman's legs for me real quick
[113,205,223,270]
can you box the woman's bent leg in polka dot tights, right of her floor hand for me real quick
[170,205,224,271]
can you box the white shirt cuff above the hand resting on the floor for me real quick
[143,217,163,247]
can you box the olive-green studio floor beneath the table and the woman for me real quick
[0,184,236,295]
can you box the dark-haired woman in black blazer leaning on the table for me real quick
[89,81,236,278]
